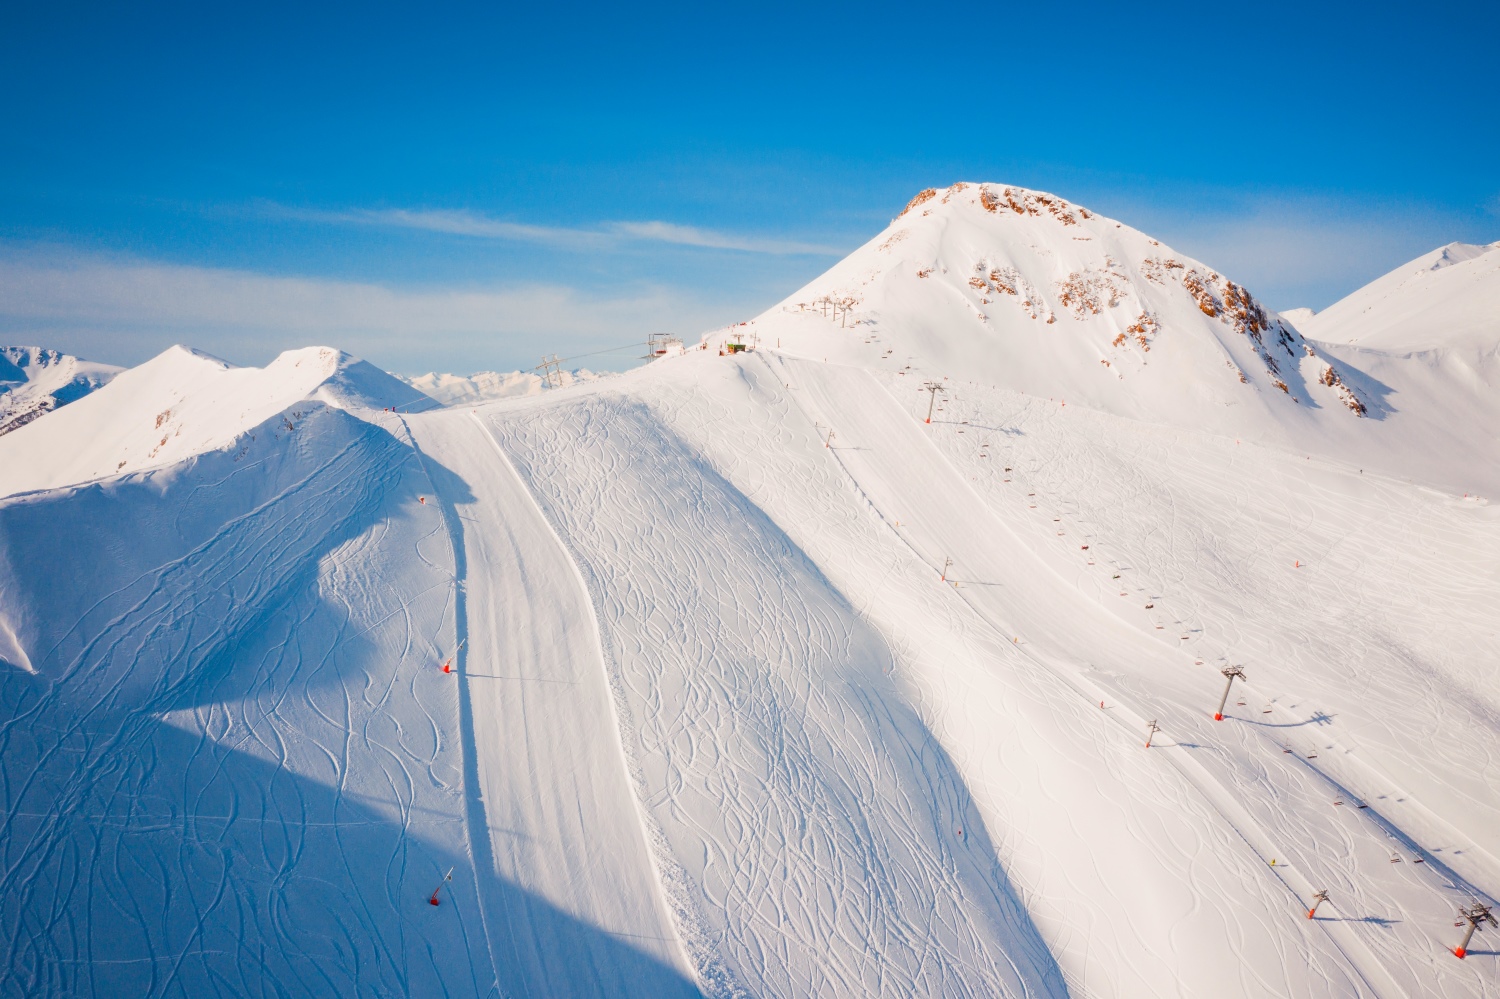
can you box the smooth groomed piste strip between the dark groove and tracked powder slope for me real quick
[410,411,696,996]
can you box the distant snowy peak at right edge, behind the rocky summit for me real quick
[1298,242,1500,353]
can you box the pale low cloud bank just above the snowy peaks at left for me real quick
[0,246,756,372]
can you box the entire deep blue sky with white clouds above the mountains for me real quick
[0,3,1500,372]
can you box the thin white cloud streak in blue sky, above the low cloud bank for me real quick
[264,204,848,257]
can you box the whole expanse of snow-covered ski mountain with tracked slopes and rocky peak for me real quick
[0,185,1500,998]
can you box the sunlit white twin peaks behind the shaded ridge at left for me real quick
[0,347,437,495]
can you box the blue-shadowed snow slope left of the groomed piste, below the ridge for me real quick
[0,408,507,996]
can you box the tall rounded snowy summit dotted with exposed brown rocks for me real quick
[747,183,1367,432]
